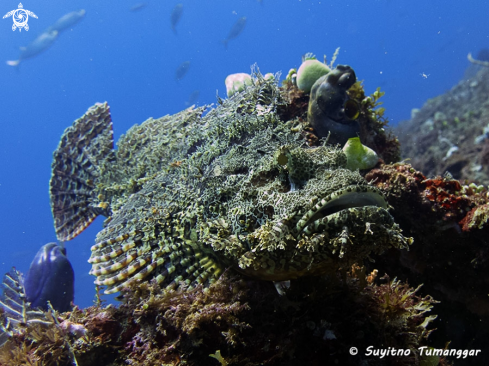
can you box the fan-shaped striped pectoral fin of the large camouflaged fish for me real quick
[89,180,222,294]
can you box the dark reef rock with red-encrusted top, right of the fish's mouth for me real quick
[366,163,489,364]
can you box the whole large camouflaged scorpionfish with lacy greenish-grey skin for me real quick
[50,66,412,293]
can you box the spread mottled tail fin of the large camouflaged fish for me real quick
[49,103,114,241]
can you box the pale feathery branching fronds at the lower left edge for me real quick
[0,268,50,347]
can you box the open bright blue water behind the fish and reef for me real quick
[0,0,489,307]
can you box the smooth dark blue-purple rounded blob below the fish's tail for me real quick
[24,243,75,312]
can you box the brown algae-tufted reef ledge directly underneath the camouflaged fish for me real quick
[0,266,436,366]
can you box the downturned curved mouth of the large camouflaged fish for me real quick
[295,185,389,235]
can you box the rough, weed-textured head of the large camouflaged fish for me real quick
[199,107,412,281]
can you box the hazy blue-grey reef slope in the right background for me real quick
[396,65,489,186]
